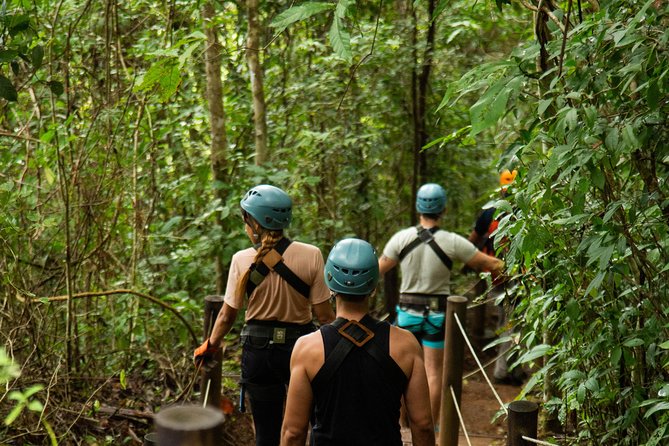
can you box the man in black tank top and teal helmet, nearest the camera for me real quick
[281,239,435,446]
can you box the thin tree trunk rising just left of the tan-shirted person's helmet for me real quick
[202,0,228,294]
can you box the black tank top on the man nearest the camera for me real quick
[311,315,408,446]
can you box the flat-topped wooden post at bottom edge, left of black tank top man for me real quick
[155,405,223,446]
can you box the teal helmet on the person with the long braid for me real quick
[239,184,293,230]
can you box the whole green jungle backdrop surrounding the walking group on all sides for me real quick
[0,0,669,444]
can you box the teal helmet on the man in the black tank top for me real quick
[324,238,379,296]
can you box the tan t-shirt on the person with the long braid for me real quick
[224,241,330,324]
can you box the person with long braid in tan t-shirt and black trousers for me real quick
[194,185,334,446]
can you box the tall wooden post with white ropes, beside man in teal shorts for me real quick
[439,296,467,446]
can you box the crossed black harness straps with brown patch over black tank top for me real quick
[312,315,407,392]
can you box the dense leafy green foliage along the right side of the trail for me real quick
[438,1,669,445]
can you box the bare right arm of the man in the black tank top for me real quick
[404,335,435,446]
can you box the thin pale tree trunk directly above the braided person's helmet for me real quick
[246,0,268,166]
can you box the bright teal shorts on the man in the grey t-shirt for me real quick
[395,304,446,349]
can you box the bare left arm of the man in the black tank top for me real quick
[281,333,320,446]
